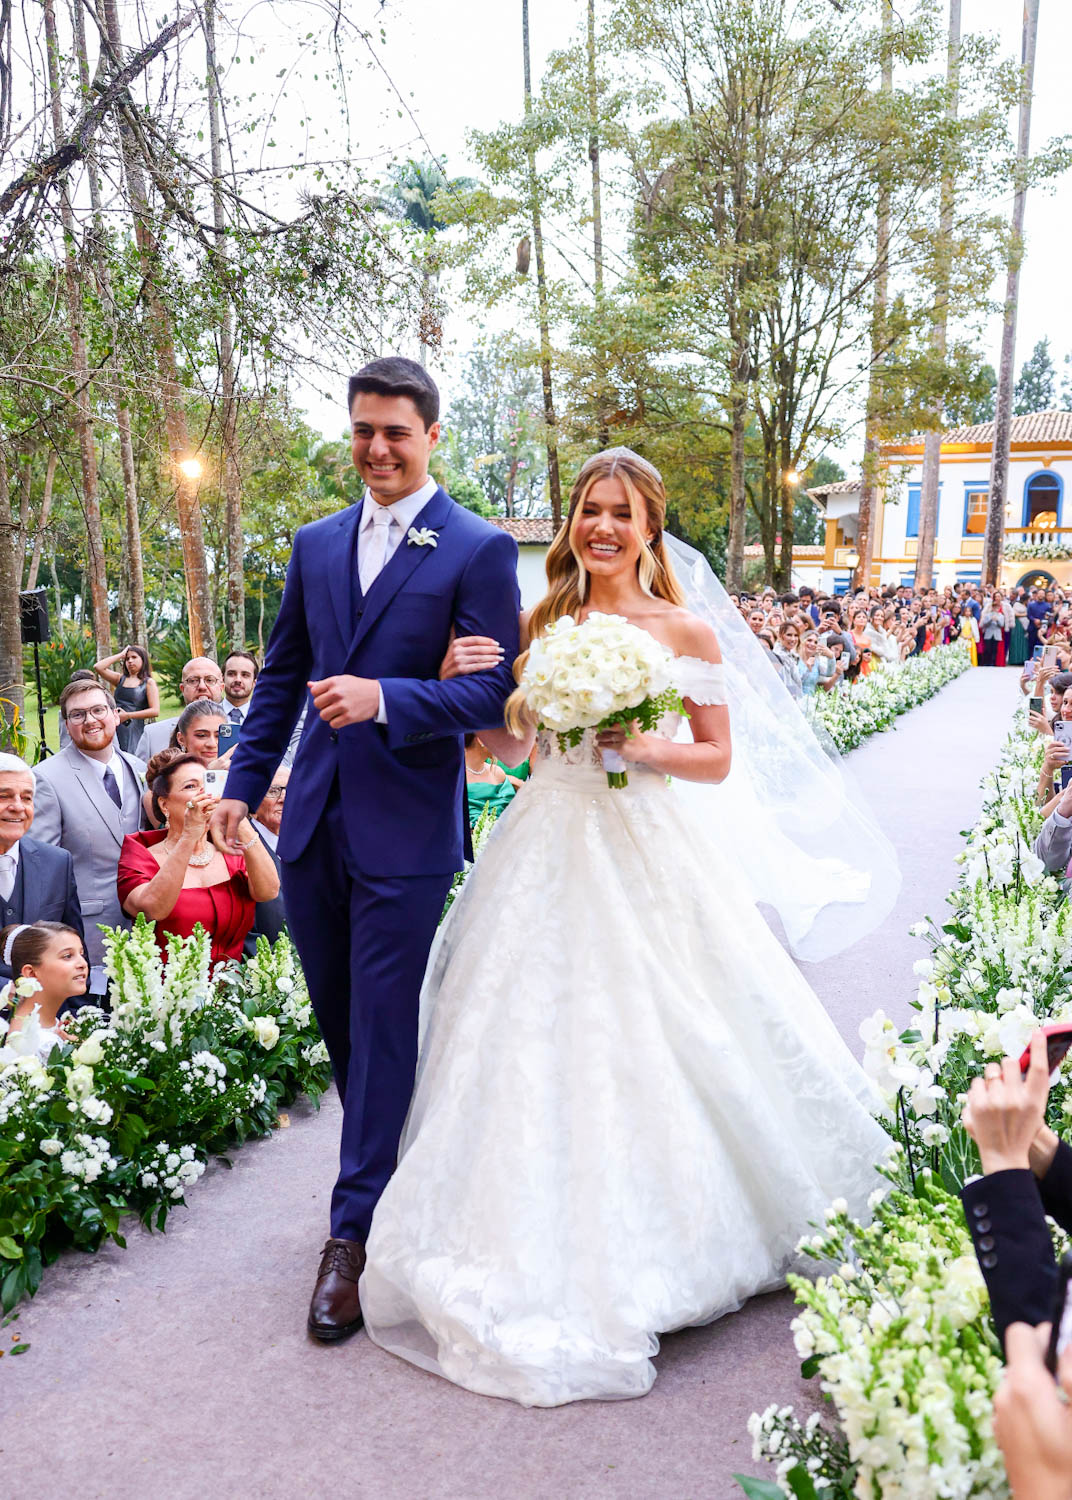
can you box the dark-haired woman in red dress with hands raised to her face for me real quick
[117,750,279,963]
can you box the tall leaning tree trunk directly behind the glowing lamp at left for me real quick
[103,0,216,662]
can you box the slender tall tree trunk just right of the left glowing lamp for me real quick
[204,0,242,651]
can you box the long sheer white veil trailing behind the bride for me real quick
[664,534,901,963]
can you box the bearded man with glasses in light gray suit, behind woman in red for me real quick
[33,681,145,995]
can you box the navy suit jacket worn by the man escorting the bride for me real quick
[226,489,520,876]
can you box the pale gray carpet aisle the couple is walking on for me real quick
[0,671,1017,1500]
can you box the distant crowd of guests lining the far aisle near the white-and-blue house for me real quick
[730,584,1072,698]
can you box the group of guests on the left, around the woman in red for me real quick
[0,647,298,1047]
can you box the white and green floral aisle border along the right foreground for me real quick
[736,708,1072,1500]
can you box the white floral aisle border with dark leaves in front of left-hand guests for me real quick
[0,917,331,1311]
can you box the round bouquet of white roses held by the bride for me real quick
[520,614,685,786]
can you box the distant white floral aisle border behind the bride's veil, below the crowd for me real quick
[804,641,972,755]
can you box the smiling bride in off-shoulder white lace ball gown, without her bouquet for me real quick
[360,449,888,1406]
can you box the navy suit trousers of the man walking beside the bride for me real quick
[280,783,451,1244]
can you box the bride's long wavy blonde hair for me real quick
[505,449,685,735]
